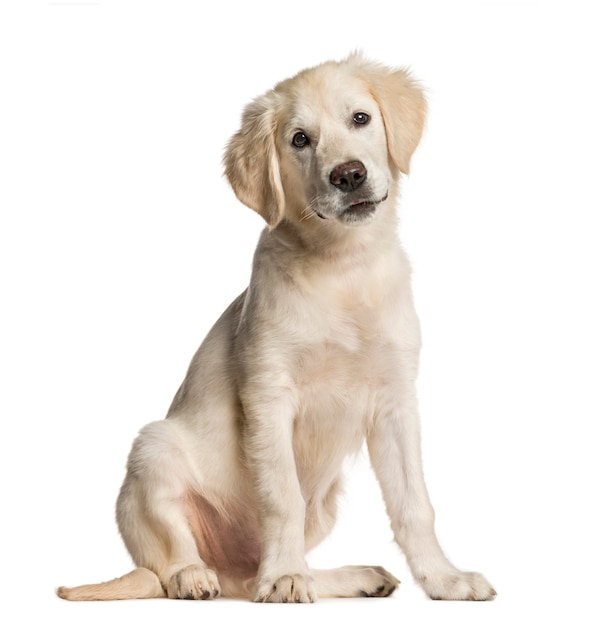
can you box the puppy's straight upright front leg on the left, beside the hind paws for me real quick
[242,389,316,602]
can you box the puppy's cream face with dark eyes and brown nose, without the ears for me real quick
[276,66,393,225]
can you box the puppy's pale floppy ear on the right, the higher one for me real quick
[365,64,426,174]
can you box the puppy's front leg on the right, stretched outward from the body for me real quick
[368,351,496,600]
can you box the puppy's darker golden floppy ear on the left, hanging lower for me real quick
[223,94,284,227]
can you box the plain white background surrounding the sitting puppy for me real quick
[0,0,606,625]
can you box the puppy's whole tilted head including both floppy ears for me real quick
[224,54,425,227]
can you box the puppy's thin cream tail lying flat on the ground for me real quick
[57,567,166,600]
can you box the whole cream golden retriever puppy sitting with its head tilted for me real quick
[58,54,495,602]
